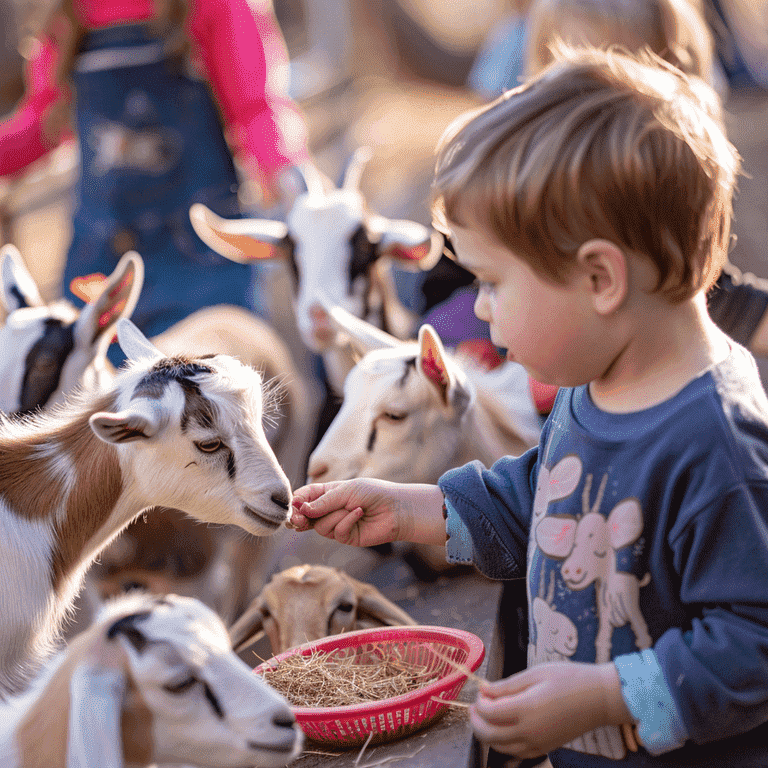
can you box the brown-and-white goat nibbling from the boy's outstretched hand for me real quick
[0,318,291,691]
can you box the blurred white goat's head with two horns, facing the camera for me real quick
[189,148,444,390]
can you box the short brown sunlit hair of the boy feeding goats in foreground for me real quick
[433,46,739,302]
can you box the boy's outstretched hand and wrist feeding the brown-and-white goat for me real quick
[288,478,445,547]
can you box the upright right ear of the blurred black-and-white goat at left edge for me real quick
[75,251,144,351]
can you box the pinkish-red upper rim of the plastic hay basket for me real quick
[253,624,485,722]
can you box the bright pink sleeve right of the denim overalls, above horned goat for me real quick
[190,0,307,179]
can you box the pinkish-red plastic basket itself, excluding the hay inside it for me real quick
[254,626,485,747]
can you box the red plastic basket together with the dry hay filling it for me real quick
[255,626,485,747]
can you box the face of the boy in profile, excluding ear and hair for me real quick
[451,226,601,386]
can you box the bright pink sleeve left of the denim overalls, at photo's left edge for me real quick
[0,39,68,176]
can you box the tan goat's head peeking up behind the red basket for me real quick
[229,565,416,654]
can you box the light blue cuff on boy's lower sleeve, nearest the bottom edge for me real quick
[613,650,688,755]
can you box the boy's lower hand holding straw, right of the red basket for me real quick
[469,661,632,758]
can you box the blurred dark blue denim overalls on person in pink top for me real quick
[63,25,253,364]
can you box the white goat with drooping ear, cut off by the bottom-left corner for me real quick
[0,593,303,768]
